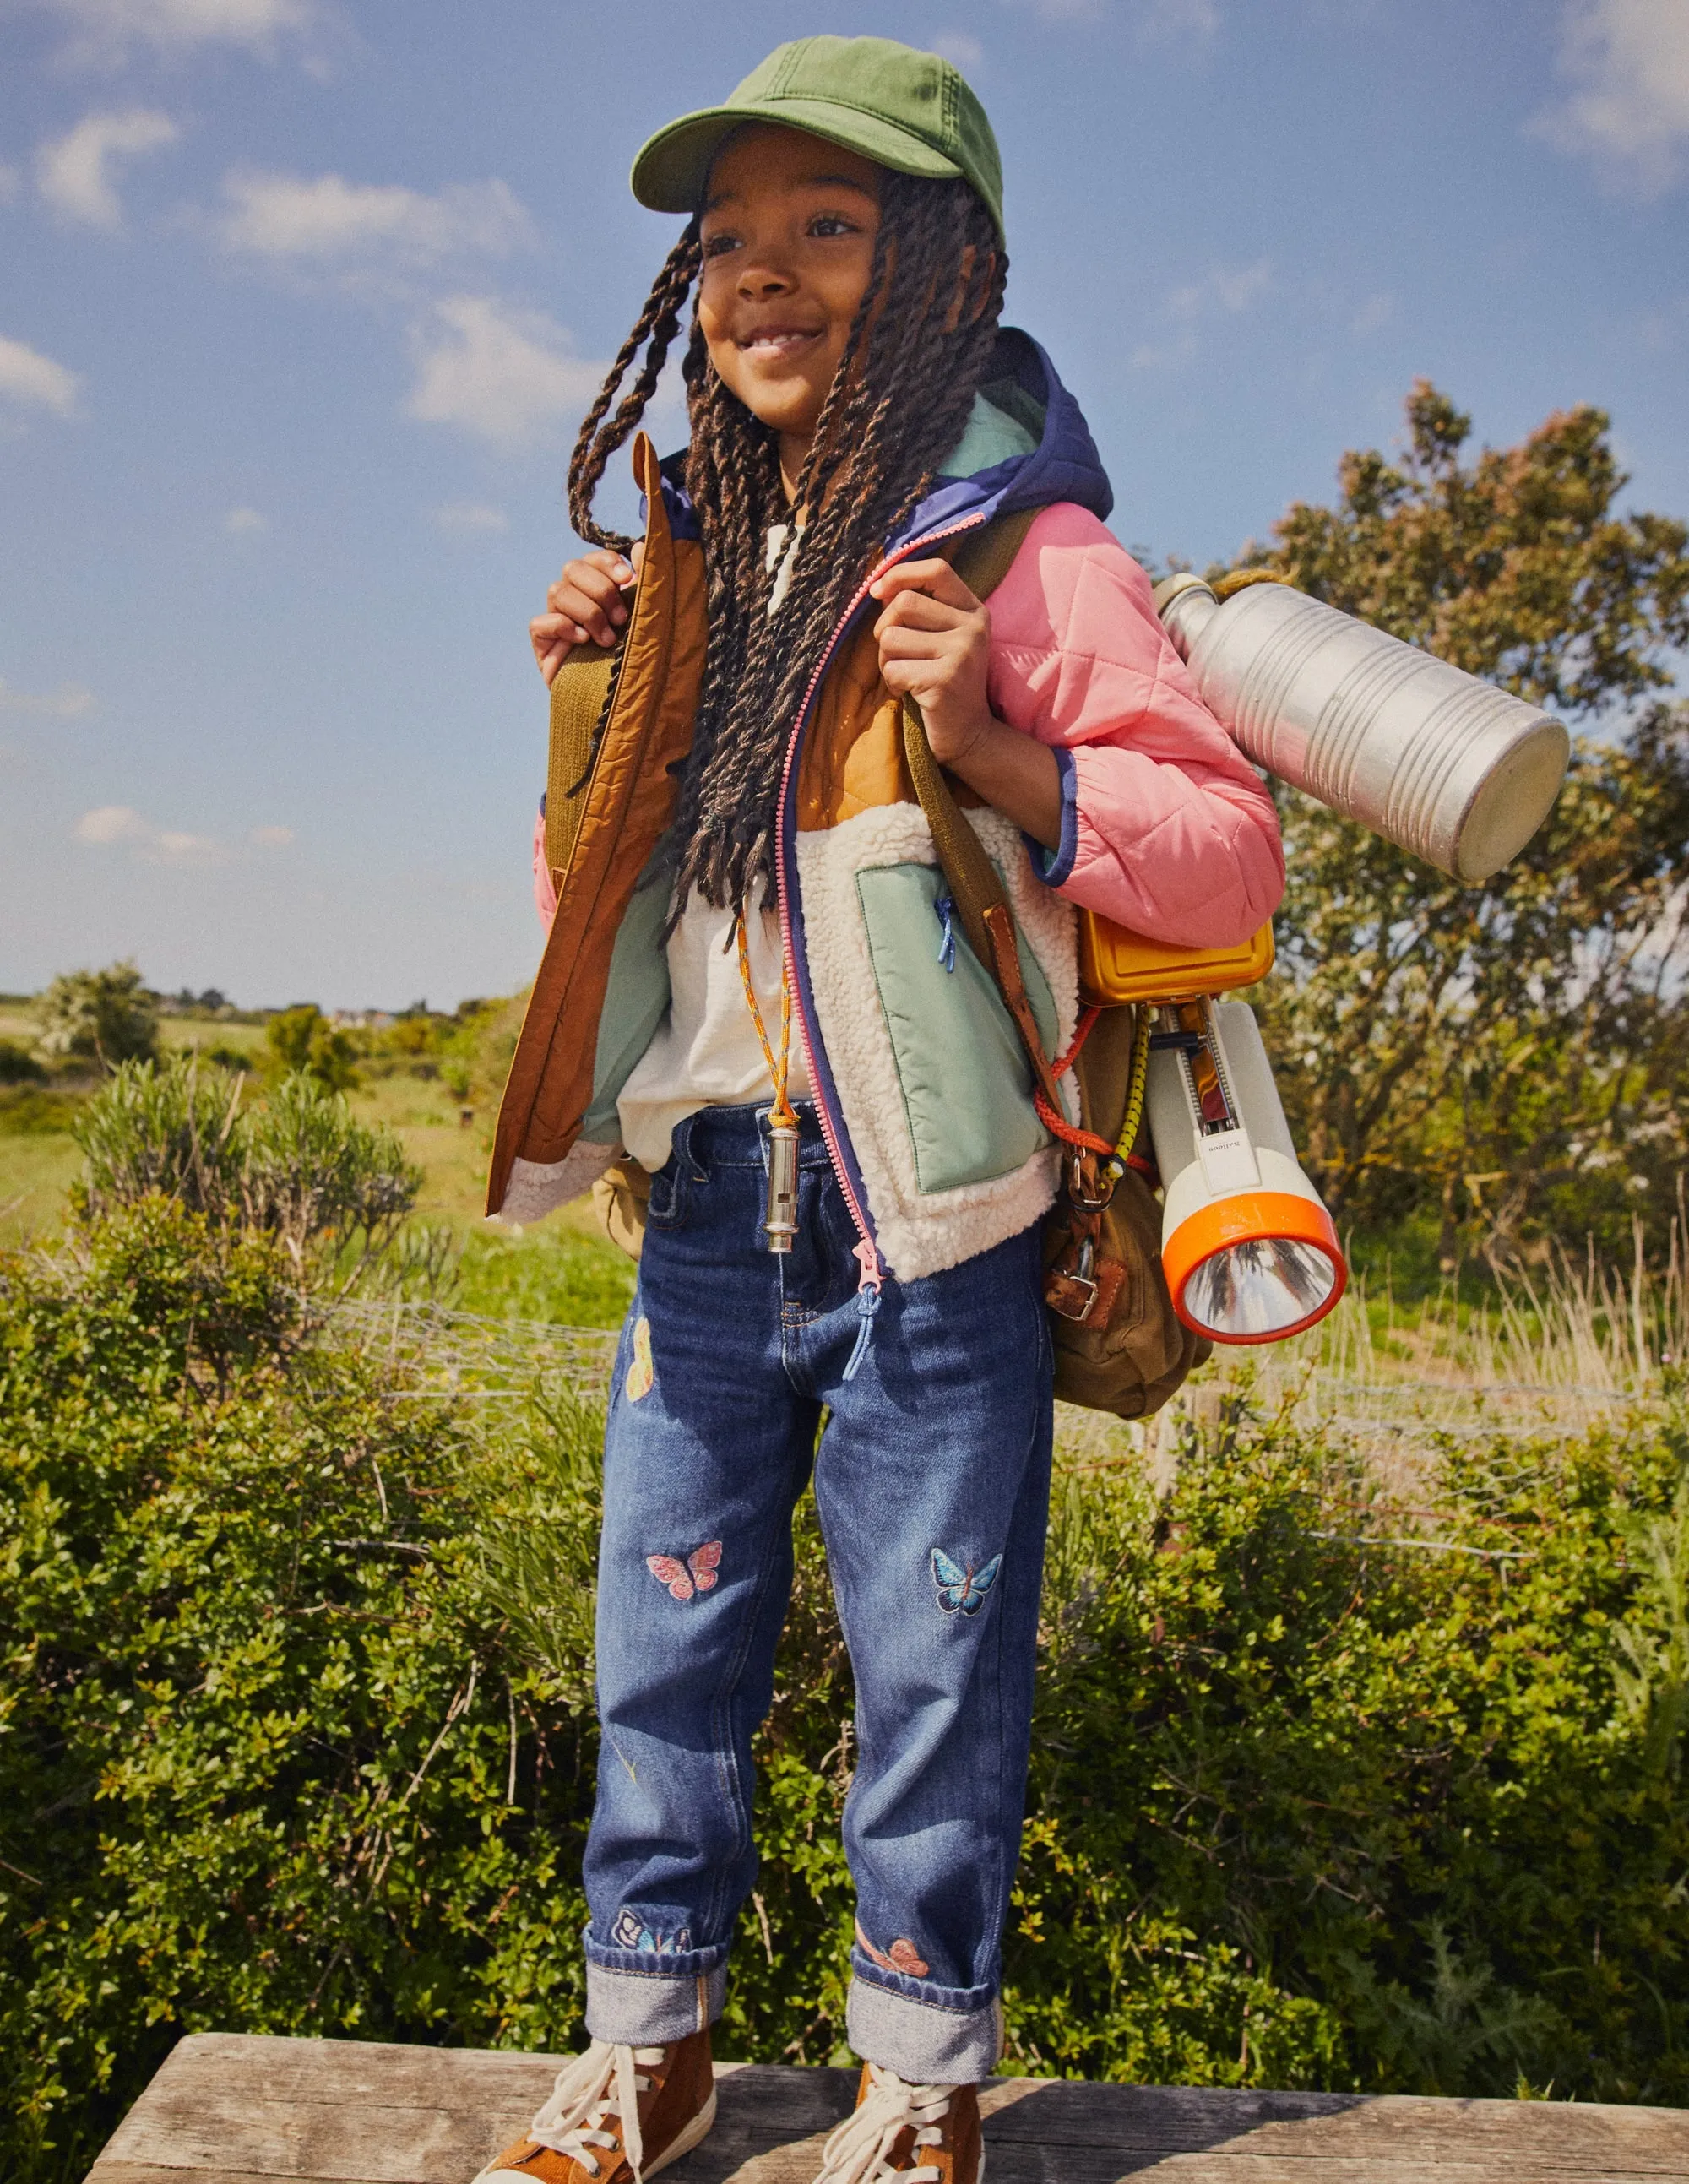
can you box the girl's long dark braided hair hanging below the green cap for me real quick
[568,172,1007,921]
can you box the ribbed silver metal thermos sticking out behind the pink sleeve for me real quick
[1156,574,1571,884]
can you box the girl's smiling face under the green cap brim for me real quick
[697,122,881,470]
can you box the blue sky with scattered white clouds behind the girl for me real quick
[0,0,1689,1007]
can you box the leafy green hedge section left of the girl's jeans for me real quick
[0,1197,595,2180]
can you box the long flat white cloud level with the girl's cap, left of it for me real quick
[216,172,533,271]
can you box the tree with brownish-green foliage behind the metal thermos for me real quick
[1243,380,1689,1253]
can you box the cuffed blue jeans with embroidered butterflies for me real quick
[585,1107,1051,2083]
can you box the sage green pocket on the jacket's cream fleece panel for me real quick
[856,865,1056,1193]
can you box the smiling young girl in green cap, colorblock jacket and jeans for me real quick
[487,37,1283,2184]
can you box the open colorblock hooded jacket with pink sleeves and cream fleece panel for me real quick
[487,329,1284,1285]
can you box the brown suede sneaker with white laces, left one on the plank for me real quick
[476,2031,712,2184]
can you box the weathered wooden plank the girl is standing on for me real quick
[90,2034,1689,2184]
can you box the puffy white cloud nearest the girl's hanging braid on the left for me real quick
[405,295,606,448]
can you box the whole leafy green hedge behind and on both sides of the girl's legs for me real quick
[0,1195,1689,2184]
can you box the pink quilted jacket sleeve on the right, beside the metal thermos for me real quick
[990,503,1284,948]
